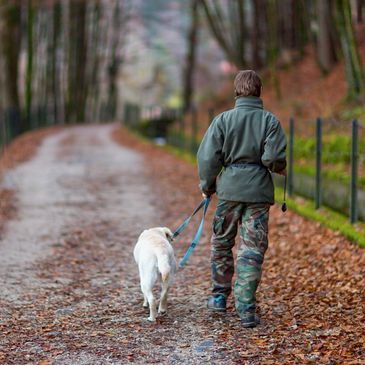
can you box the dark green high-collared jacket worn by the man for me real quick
[197,96,286,204]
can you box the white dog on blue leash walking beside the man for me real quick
[134,227,176,322]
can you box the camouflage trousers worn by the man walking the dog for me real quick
[211,200,270,318]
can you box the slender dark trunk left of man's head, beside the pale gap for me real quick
[183,0,199,111]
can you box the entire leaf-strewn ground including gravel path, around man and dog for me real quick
[0,125,365,365]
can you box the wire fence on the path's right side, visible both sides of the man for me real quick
[124,104,365,223]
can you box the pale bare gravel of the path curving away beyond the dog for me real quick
[0,126,155,300]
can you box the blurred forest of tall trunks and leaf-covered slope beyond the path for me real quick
[0,0,365,226]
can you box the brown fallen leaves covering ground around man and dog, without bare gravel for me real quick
[0,123,365,364]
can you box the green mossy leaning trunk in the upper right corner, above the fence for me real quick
[336,0,365,99]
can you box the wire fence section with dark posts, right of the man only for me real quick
[288,118,365,223]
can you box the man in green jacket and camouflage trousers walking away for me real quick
[197,70,286,327]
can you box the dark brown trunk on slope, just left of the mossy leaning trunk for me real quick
[317,0,337,73]
